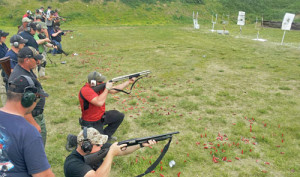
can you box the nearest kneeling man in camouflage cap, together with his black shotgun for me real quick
[64,127,179,177]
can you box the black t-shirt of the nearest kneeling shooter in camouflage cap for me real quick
[64,143,111,177]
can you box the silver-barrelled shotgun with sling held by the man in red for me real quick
[92,70,151,94]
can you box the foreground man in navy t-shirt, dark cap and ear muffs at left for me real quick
[0,75,55,177]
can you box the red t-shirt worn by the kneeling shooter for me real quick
[78,83,105,121]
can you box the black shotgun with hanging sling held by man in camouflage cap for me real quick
[84,131,179,176]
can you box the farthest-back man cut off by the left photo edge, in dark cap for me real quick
[0,30,9,105]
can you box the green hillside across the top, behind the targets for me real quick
[0,0,300,26]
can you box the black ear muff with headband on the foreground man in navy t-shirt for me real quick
[21,75,37,108]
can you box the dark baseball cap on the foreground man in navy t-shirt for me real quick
[7,75,49,97]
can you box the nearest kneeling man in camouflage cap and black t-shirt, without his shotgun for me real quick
[64,127,156,177]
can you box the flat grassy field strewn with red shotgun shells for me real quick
[2,24,300,177]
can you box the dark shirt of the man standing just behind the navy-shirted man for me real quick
[8,64,46,110]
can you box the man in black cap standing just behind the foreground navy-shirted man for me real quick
[8,47,47,145]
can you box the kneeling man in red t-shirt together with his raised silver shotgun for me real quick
[66,71,150,151]
